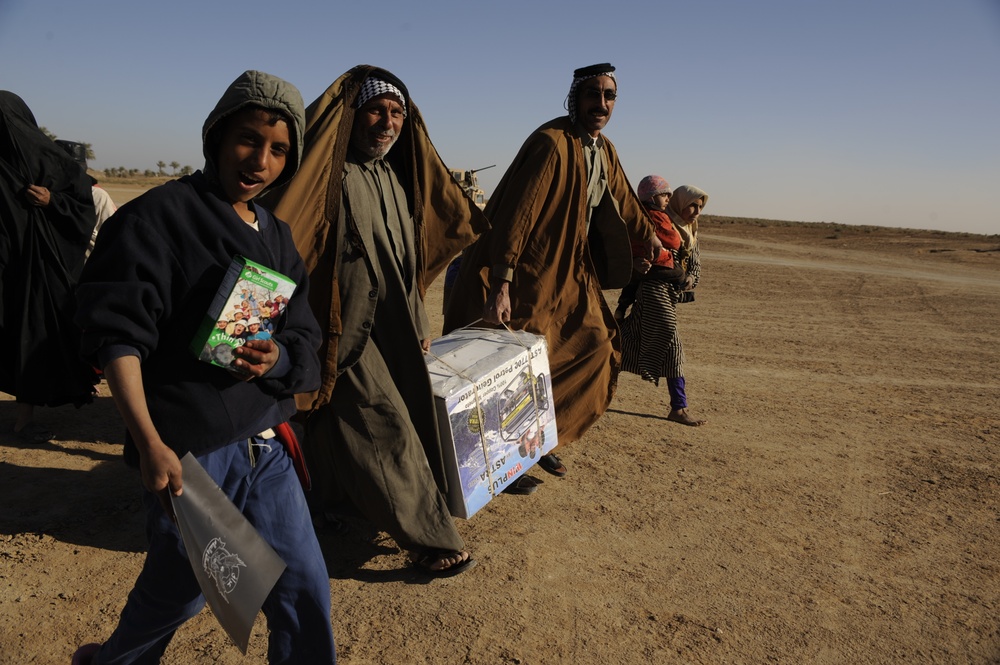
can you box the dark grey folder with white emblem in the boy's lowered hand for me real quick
[171,453,285,654]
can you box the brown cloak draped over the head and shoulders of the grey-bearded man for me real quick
[264,65,489,410]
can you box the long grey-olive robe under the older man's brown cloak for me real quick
[306,154,465,551]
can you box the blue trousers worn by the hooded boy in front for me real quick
[92,438,336,665]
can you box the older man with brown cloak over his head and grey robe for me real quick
[271,65,488,575]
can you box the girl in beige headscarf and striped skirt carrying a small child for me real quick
[621,185,708,427]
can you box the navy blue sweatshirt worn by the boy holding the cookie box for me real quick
[76,171,320,462]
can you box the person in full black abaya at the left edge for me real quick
[0,90,97,442]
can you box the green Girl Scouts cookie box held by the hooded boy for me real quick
[191,256,295,369]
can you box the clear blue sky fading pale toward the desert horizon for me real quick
[0,0,1000,234]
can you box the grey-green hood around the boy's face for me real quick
[201,70,306,189]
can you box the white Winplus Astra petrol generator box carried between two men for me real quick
[426,328,558,519]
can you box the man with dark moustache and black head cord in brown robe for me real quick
[445,63,659,493]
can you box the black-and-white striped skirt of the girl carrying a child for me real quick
[621,280,684,385]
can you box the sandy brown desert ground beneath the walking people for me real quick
[0,195,1000,665]
